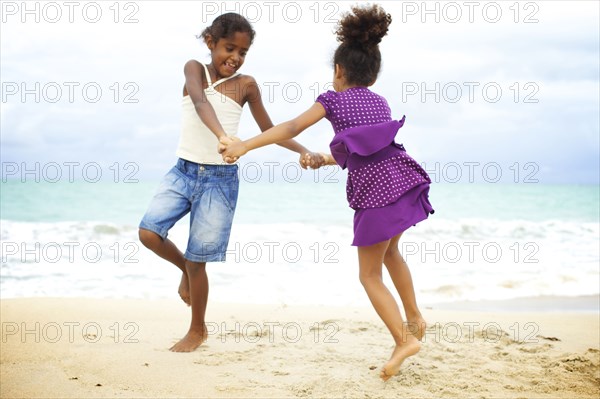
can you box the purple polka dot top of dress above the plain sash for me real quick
[317,87,392,134]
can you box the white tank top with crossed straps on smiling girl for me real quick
[176,64,242,165]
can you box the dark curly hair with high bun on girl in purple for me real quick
[333,4,392,86]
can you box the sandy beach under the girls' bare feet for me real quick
[0,298,600,398]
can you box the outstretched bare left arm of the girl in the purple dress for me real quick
[222,102,325,158]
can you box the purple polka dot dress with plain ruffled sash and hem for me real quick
[317,87,433,246]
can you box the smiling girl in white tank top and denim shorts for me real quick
[139,13,319,352]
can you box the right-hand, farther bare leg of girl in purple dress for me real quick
[383,233,427,340]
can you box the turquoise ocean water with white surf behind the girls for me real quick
[0,174,600,305]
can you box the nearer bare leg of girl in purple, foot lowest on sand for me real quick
[358,240,421,381]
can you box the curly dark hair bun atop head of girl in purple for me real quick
[335,4,392,50]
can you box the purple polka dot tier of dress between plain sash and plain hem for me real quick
[346,152,431,209]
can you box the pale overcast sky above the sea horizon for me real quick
[0,1,600,184]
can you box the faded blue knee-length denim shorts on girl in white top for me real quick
[139,159,239,262]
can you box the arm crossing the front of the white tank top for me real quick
[183,60,227,139]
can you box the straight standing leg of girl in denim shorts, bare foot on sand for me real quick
[170,260,208,352]
